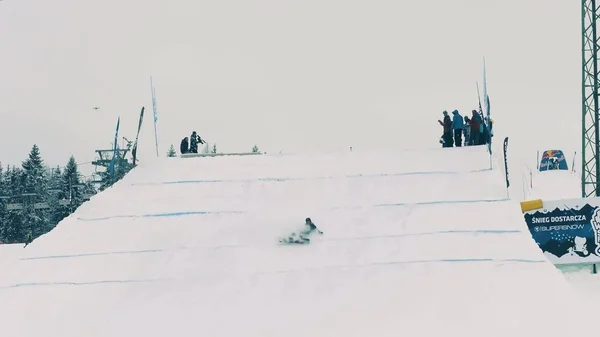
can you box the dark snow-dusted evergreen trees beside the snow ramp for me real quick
[0,145,97,243]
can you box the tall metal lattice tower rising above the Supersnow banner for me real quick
[581,0,600,198]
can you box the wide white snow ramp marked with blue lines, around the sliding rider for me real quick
[0,147,582,337]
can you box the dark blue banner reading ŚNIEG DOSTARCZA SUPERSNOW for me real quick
[524,198,600,265]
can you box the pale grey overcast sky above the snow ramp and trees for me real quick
[0,0,581,176]
